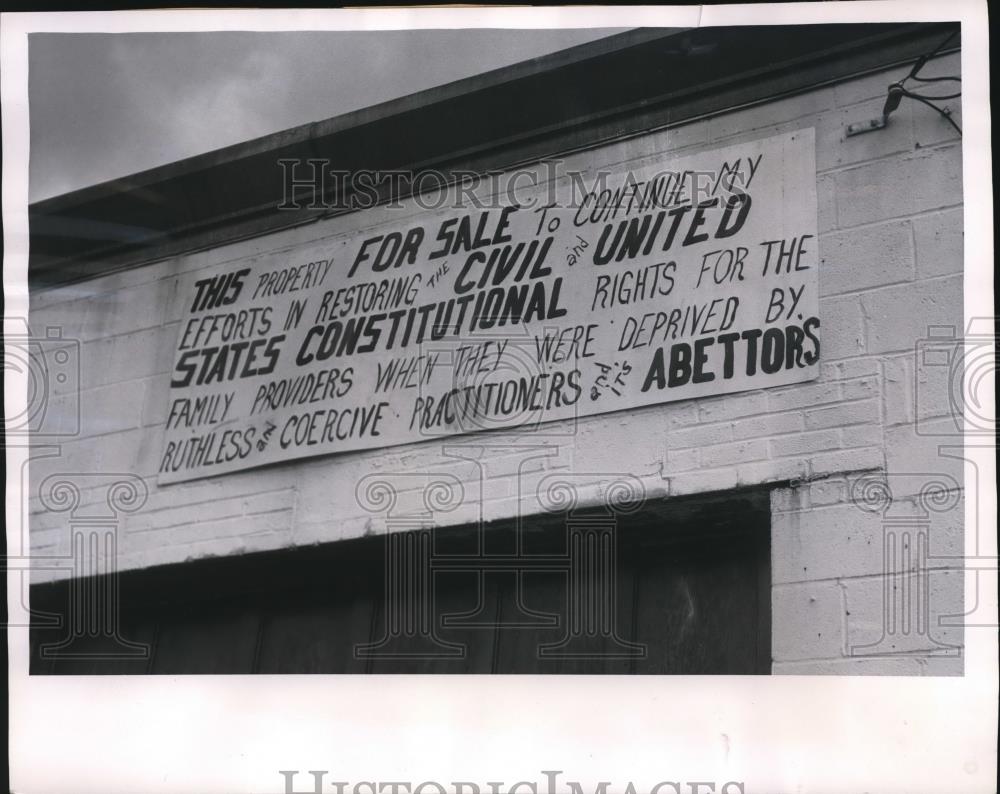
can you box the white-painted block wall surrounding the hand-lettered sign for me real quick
[28,55,963,674]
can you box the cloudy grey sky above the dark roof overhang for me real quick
[28,29,618,201]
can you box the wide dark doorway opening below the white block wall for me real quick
[31,489,771,675]
